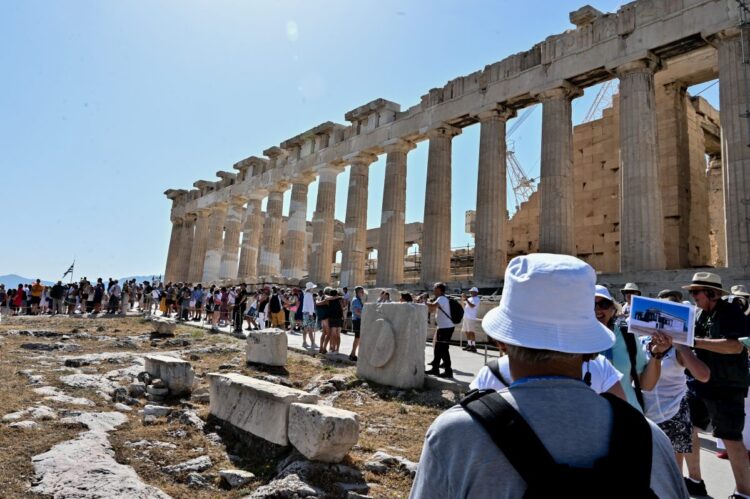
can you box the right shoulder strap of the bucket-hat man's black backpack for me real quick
[601,393,656,497]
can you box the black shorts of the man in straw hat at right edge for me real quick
[687,390,747,441]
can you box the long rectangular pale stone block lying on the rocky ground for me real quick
[208,373,318,445]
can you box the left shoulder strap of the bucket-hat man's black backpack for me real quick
[460,390,556,484]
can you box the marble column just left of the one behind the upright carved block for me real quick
[339,153,377,287]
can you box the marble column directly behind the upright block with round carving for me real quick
[376,139,415,287]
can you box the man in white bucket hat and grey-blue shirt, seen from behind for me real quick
[411,253,688,498]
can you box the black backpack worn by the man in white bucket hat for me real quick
[460,390,657,499]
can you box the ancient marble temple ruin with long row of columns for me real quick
[165,0,750,286]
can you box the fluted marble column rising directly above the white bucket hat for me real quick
[537,84,581,255]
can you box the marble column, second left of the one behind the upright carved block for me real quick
[310,163,343,286]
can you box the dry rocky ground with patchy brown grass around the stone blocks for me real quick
[0,316,457,498]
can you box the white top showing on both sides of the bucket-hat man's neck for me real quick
[469,355,627,400]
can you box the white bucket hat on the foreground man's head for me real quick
[482,253,615,353]
